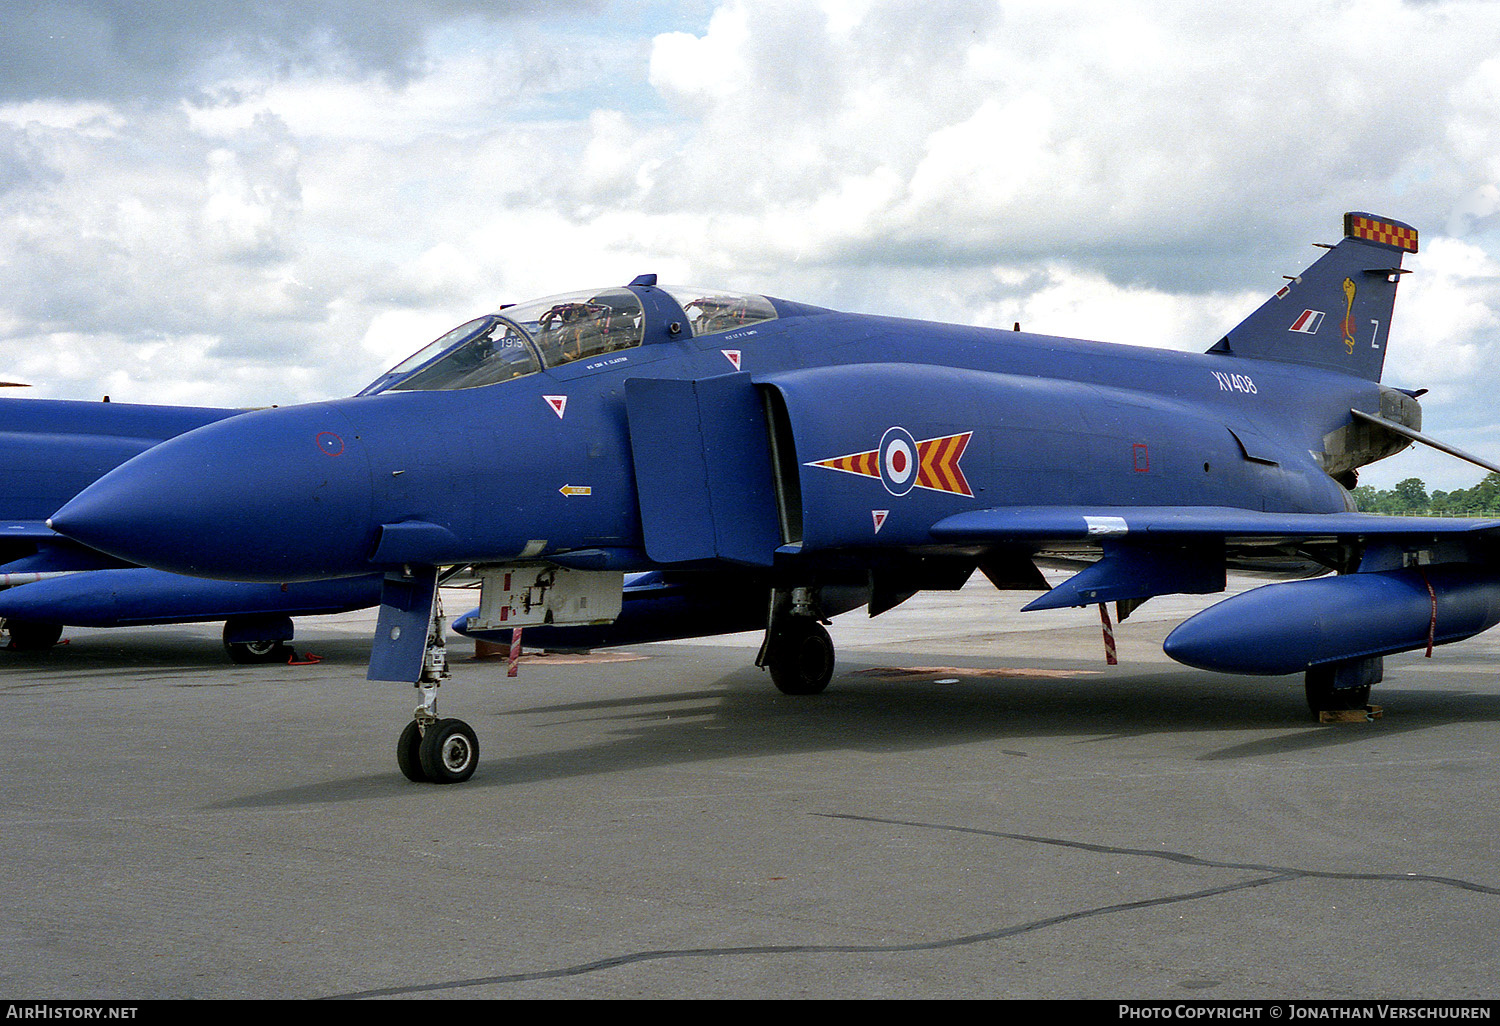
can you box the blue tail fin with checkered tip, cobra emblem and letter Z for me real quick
[1209,213,1416,381]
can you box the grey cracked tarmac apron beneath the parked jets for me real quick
[0,585,1500,1001]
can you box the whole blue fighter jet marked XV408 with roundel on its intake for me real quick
[50,213,1500,783]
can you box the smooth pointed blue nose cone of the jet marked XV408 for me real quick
[50,404,375,582]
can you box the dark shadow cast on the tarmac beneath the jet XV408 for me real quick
[208,648,1500,807]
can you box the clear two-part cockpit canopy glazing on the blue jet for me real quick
[360,288,777,396]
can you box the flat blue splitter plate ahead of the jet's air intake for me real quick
[626,374,782,567]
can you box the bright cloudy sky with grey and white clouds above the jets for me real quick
[0,0,1500,489]
